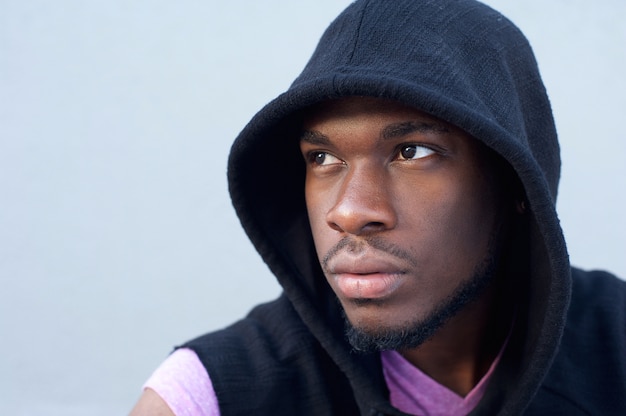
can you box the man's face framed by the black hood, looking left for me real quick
[300,97,500,346]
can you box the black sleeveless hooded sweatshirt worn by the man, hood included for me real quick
[180,0,626,416]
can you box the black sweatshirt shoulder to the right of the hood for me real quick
[537,269,626,415]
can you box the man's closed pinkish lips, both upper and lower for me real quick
[329,257,406,299]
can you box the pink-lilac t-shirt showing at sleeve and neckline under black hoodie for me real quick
[144,348,502,416]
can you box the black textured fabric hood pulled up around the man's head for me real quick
[228,0,570,413]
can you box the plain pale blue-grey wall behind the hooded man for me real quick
[0,0,626,416]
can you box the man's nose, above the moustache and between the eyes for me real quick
[326,169,397,235]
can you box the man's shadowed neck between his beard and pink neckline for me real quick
[399,289,511,396]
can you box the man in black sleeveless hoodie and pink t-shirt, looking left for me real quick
[129,0,626,415]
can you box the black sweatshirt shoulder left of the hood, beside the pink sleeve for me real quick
[178,297,354,415]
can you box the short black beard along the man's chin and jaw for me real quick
[344,244,497,353]
